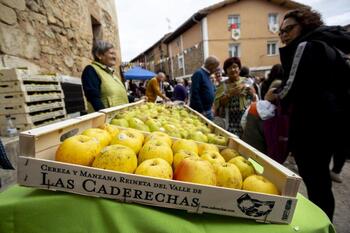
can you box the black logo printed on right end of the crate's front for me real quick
[237,194,275,217]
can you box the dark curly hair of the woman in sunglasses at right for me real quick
[283,7,324,34]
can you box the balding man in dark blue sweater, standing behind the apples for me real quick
[190,56,220,120]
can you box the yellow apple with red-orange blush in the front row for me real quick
[174,157,216,185]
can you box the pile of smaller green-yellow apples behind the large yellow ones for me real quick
[110,103,227,146]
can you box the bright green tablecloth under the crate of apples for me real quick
[0,186,335,233]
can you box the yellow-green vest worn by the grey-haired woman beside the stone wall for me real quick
[88,61,129,113]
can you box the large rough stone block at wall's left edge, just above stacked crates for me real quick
[0,23,40,58]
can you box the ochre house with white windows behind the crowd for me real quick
[164,0,305,78]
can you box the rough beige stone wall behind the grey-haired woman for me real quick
[0,0,121,76]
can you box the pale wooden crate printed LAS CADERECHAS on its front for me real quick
[18,109,301,223]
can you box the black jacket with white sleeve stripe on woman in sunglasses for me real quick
[280,26,350,151]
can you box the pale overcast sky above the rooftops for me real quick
[115,0,350,62]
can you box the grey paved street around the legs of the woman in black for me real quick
[286,157,350,233]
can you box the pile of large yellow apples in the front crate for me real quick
[56,124,279,195]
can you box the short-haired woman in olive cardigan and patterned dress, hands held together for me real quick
[214,57,256,137]
